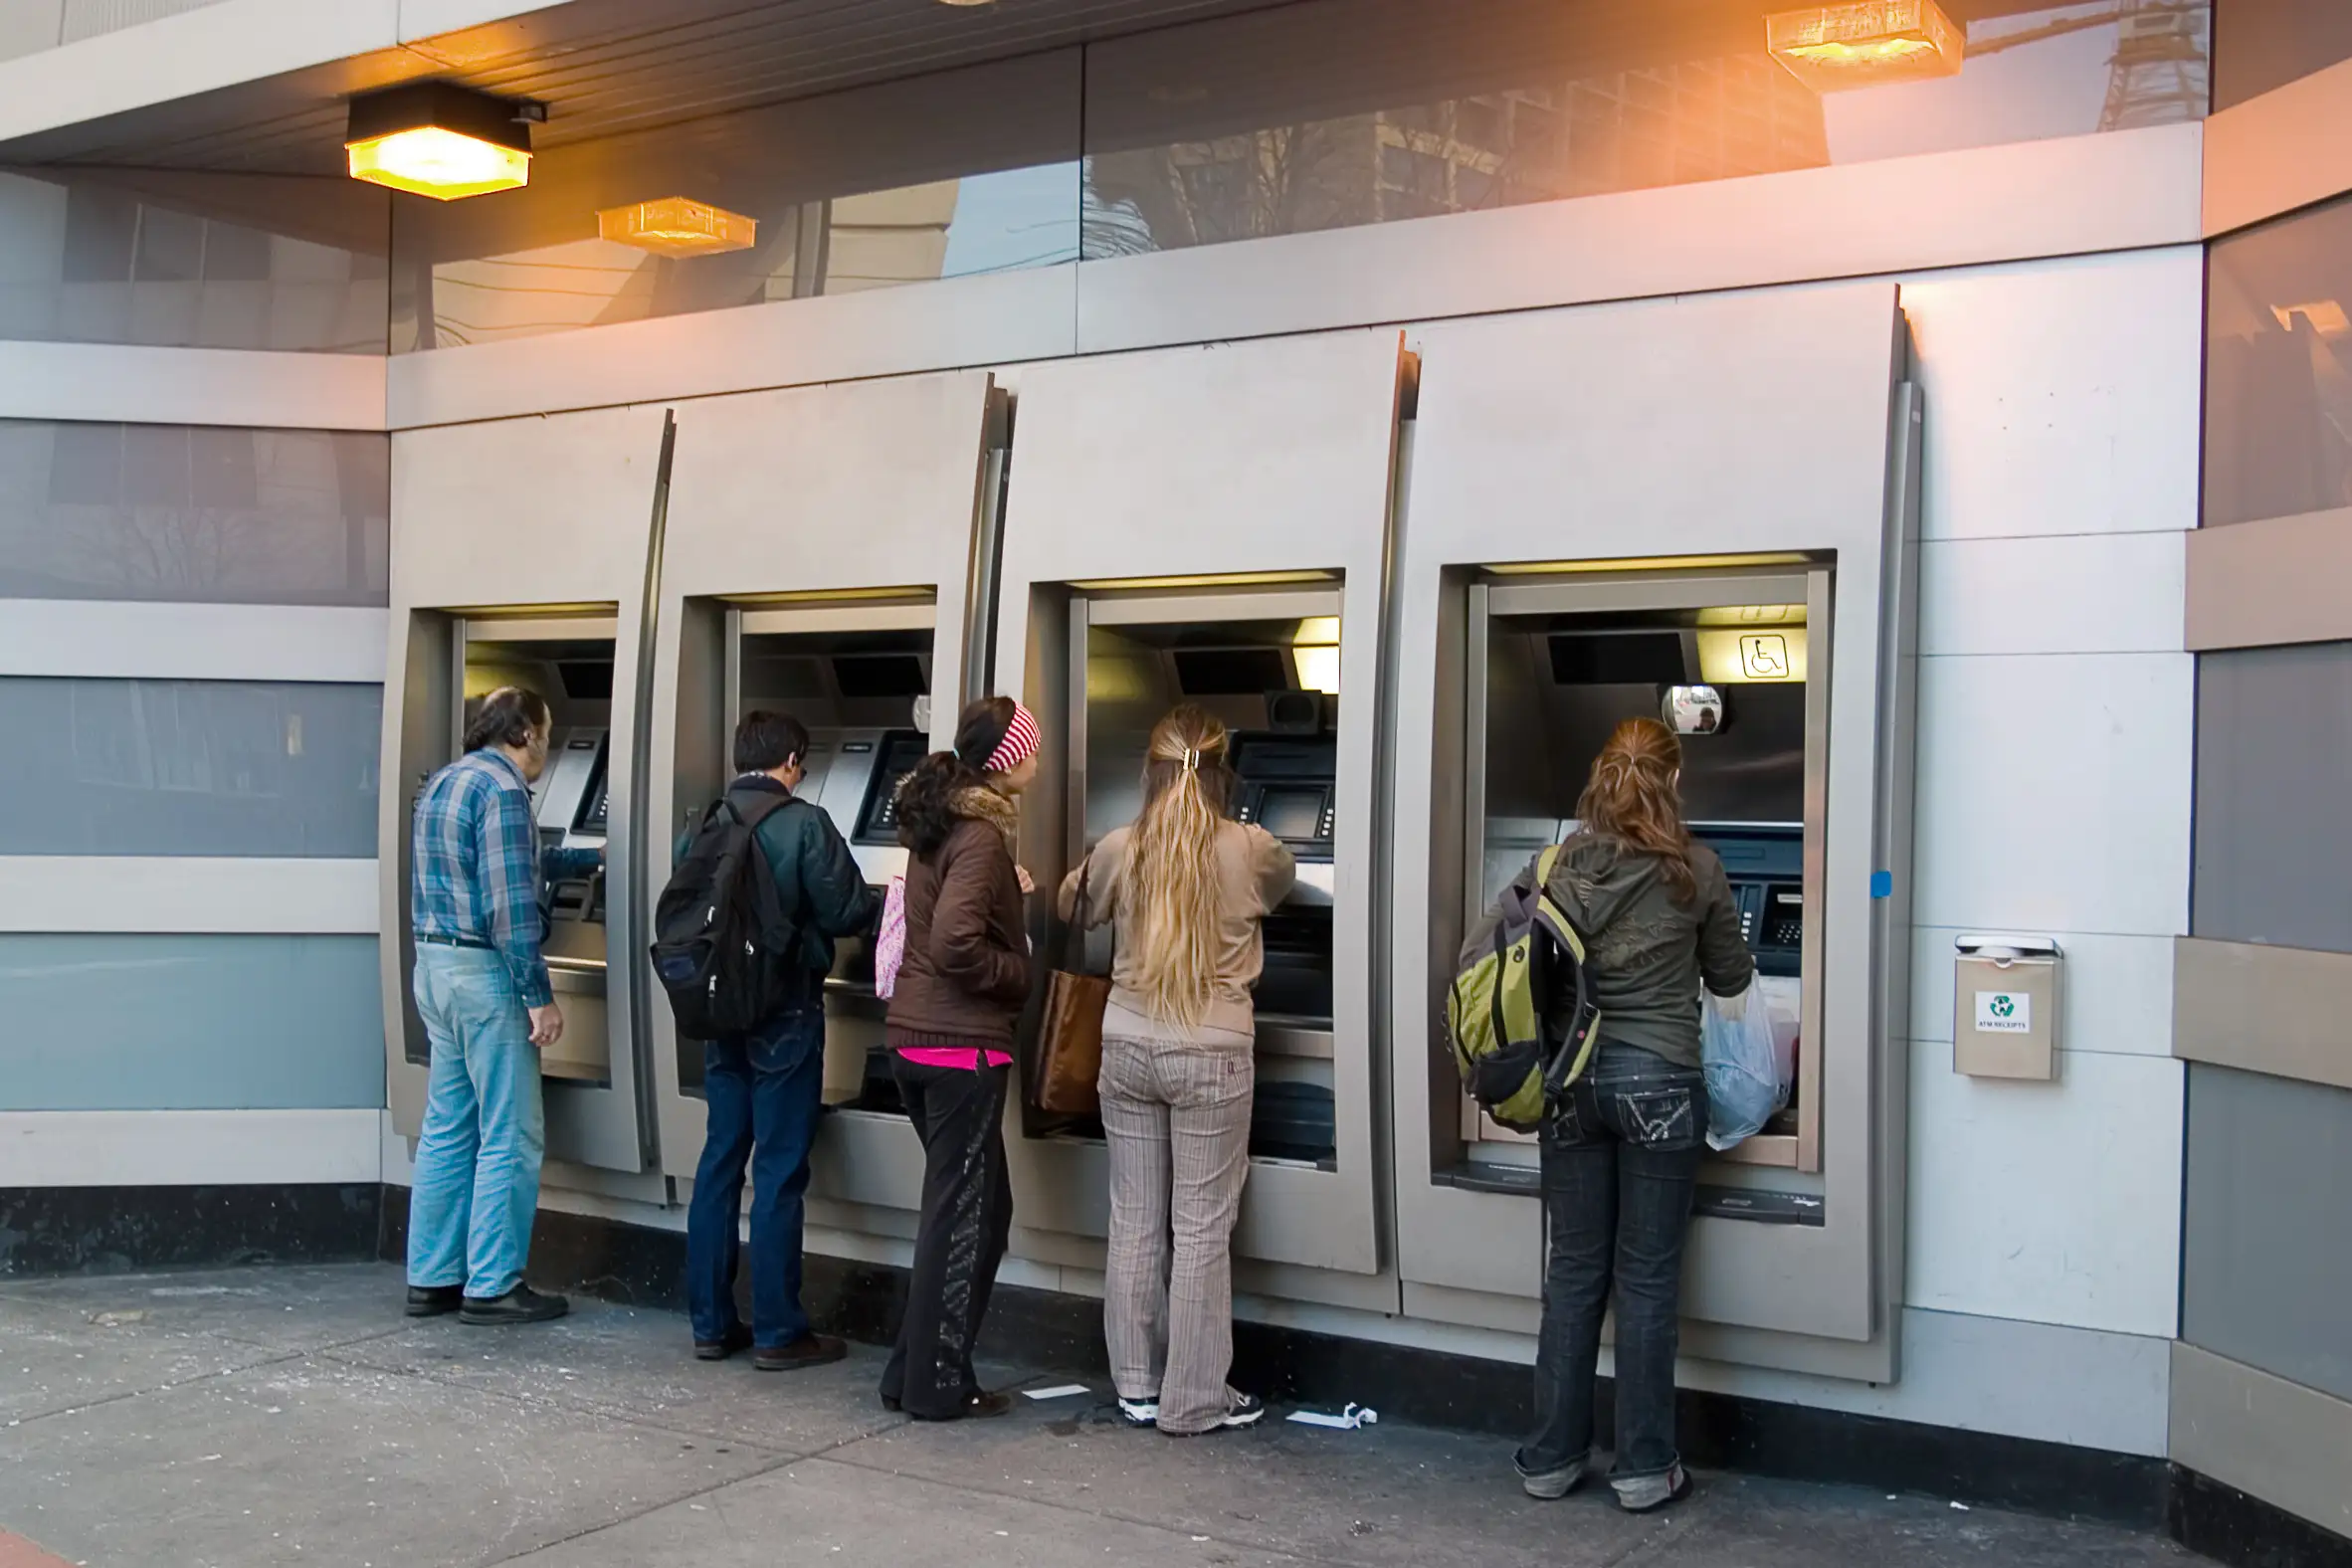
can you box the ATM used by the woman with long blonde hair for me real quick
[995,331,1411,1311]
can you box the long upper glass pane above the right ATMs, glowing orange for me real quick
[1084,0,2211,259]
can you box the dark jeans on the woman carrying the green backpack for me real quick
[1519,1042,1707,1481]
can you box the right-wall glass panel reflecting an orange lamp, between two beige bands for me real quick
[2204,197,2352,526]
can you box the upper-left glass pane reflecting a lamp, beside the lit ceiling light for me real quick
[393,50,1079,352]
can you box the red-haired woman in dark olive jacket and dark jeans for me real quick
[1463,719,1755,1514]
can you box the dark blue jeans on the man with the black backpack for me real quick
[686,999,826,1349]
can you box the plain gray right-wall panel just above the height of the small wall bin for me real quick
[2190,642,2352,952]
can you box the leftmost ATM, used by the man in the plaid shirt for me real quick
[381,407,671,1184]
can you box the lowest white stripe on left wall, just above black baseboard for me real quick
[0,1109,383,1187]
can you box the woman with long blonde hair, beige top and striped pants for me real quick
[1061,702,1296,1437]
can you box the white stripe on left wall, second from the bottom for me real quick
[0,856,381,935]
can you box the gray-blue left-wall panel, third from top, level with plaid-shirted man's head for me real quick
[0,677,383,858]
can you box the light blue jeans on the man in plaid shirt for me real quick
[409,942,548,1300]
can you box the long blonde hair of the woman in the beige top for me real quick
[1119,702,1233,1030]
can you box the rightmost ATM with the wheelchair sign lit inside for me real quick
[1388,283,1924,1382]
